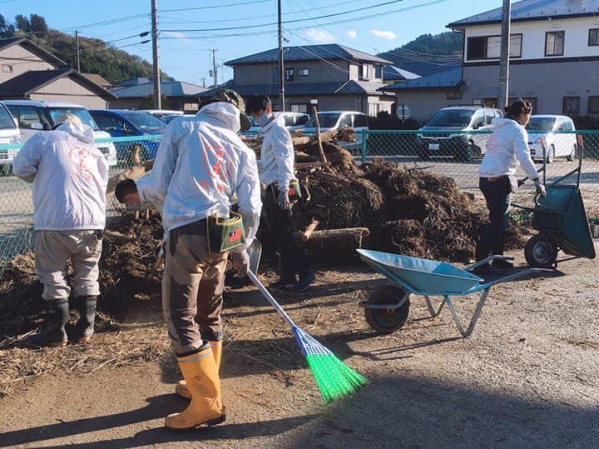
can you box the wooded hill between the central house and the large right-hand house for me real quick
[377,31,464,76]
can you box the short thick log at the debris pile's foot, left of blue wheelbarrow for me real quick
[306,228,370,263]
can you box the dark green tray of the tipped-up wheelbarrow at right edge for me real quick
[531,185,595,259]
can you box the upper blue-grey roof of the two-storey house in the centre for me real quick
[225,44,391,66]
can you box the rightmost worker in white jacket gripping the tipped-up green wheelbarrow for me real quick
[476,98,545,274]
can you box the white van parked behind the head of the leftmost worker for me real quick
[4,100,117,167]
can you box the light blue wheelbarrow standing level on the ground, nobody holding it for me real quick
[357,249,551,337]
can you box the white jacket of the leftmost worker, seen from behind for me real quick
[13,123,108,231]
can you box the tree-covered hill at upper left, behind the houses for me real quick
[0,14,173,84]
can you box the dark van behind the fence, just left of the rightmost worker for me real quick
[417,106,503,161]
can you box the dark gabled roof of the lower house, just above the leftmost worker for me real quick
[0,68,116,100]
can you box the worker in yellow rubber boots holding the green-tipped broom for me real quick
[115,89,262,430]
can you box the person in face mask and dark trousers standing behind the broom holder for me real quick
[245,95,315,292]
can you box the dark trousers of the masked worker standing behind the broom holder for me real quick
[264,184,311,280]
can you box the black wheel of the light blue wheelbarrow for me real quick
[364,285,410,334]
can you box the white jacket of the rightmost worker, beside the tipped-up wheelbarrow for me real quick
[479,118,539,182]
